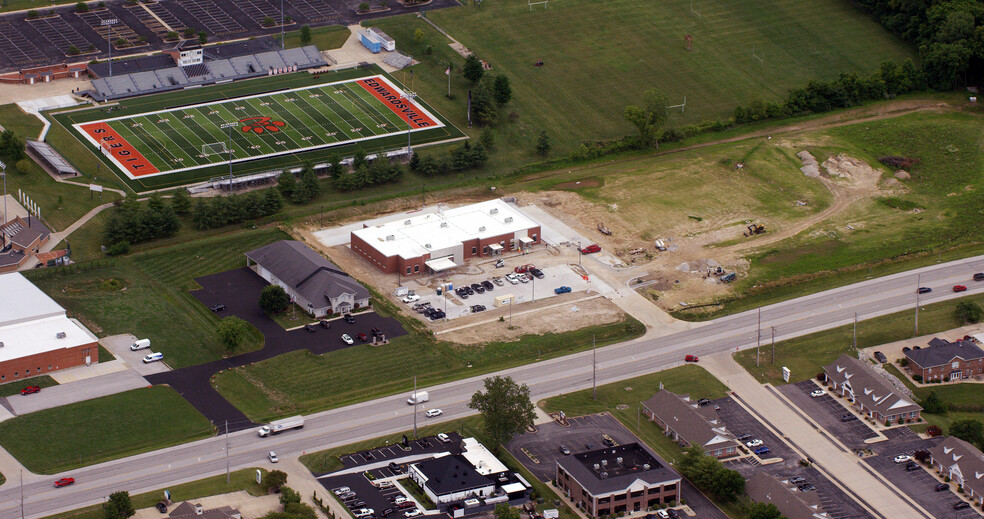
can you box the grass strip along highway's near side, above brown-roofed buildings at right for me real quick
[735,295,984,386]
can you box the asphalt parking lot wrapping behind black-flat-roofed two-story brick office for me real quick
[506,413,727,519]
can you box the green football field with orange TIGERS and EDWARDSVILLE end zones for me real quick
[72,75,444,179]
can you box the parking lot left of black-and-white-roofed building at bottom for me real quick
[318,432,461,518]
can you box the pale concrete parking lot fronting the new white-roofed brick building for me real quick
[400,259,609,319]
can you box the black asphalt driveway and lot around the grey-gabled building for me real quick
[146,267,406,431]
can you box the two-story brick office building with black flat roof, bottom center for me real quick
[557,443,681,517]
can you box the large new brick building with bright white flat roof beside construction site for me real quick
[351,199,541,276]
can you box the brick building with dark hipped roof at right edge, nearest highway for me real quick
[905,339,984,382]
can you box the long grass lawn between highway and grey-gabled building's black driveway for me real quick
[215,304,645,421]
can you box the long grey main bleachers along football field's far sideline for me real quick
[83,45,327,101]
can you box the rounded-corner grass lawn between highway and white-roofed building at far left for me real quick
[0,387,214,474]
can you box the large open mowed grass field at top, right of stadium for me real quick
[430,0,914,144]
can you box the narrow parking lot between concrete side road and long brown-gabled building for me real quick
[778,380,878,449]
